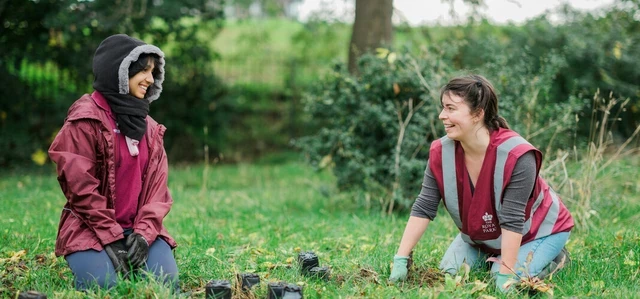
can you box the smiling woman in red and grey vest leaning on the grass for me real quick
[389,75,573,291]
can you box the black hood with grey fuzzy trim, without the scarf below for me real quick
[93,34,164,103]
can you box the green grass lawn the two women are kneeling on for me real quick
[0,158,640,298]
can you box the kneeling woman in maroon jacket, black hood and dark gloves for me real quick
[49,34,178,290]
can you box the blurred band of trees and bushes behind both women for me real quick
[0,0,640,208]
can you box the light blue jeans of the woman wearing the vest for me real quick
[440,232,571,276]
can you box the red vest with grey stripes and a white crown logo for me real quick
[429,129,573,254]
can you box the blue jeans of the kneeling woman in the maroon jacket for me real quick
[64,238,178,291]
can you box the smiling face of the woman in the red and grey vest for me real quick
[438,92,482,142]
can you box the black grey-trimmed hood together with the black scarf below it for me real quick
[93,34,164,141]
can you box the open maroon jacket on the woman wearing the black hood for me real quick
[49,94,177,256]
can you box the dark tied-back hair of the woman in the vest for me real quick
[440,75,509,130]
